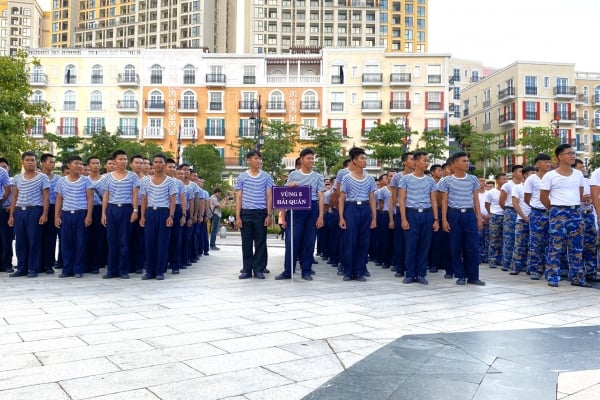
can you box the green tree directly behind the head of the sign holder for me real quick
[301,127,342,177]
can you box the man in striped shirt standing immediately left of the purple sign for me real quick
[234,150,274,279]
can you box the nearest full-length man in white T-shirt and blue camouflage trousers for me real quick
[540,144,591,287]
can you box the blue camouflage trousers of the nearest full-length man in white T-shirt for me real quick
[546,206,585,283]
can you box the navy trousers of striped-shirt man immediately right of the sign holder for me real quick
[342,202,372,278]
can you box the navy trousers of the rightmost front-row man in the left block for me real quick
[144,207,175,278]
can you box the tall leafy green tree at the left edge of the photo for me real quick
[0,51,51,169]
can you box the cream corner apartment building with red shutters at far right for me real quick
[461,61,600,170]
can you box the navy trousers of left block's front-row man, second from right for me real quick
[106,204,133,276]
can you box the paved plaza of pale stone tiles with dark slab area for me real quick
[0,234,600,400]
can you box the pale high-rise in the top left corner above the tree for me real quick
[0,0,44,56]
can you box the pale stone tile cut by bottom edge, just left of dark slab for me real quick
[149,368,292,400]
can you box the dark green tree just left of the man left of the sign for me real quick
[182,144,225,192]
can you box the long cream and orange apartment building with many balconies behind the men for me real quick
[30,48,449,172]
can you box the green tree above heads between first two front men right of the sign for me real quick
[366,120,412,169]
